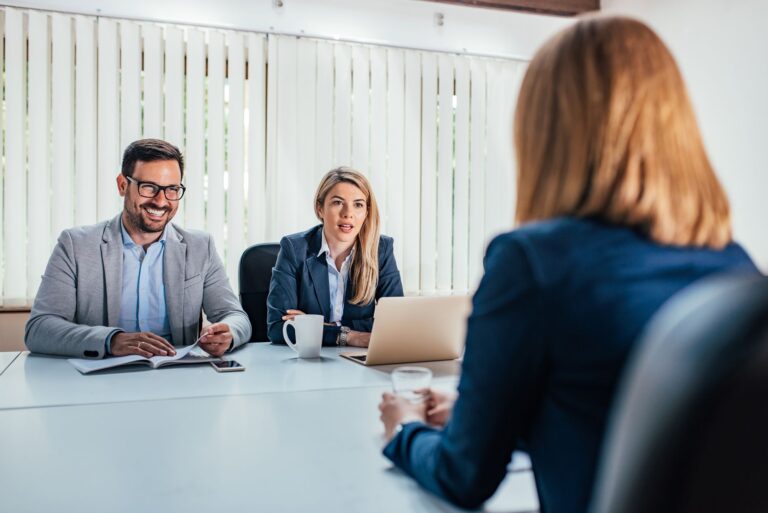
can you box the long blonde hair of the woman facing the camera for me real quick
[315,167,381,305]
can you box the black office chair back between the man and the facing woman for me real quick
[238,243,280,342]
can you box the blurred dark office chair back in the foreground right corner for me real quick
[591,276,768,513]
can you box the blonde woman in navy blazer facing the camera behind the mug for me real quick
[267,167,403,347]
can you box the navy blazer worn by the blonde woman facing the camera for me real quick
[267,225,403,345]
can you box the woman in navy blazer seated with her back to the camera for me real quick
[379,17,757,513]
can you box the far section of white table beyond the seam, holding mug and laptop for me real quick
[0,342,461,410]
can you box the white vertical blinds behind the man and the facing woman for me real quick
[0,7,525,305]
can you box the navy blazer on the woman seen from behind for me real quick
[384,218,758,513]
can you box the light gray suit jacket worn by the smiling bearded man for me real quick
[24,215,251,358]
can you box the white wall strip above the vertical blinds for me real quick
[6,0,571,59]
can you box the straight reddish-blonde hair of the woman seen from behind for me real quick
[515,17,731,248]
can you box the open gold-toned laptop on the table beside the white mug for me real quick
[341,295,471,365]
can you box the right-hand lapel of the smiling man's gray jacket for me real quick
[163,224,187,346]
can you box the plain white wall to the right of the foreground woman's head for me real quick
[602,0,768,271]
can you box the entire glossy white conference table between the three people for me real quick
[0,344,538,513]
